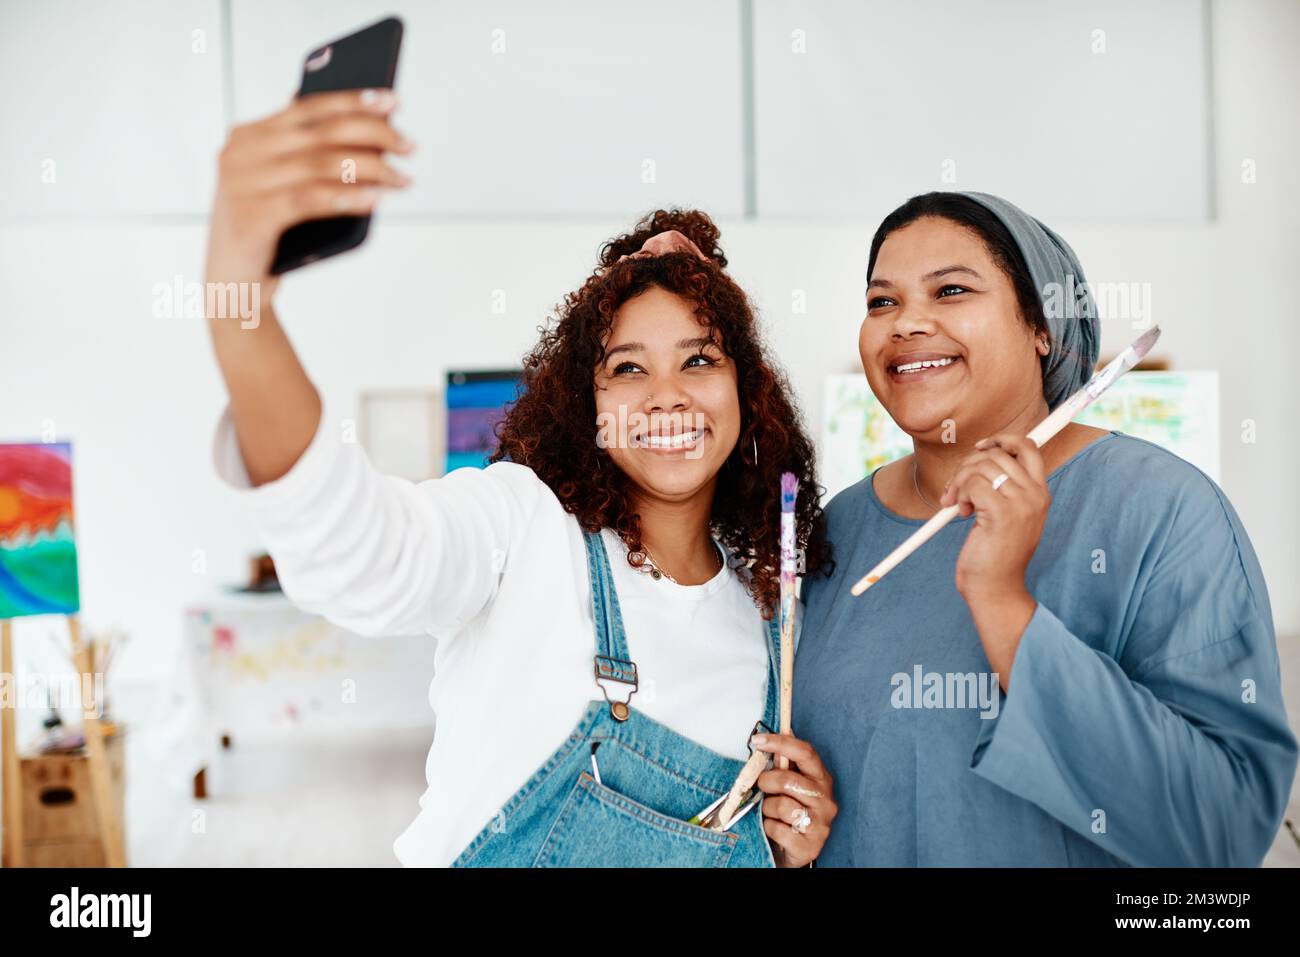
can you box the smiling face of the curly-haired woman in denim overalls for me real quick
[594,286,740,502]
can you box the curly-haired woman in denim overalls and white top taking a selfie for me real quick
[198,91,836,866]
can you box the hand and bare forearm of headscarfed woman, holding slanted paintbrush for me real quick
[940,433,1052,690]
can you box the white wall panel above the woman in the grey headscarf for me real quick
[754,0,1212,224]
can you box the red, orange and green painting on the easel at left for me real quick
[0,442,81,618]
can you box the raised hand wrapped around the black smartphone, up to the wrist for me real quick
[205,90,413,302]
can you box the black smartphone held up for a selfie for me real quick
[270,17,402,276]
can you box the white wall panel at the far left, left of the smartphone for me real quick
[0,0,225,220]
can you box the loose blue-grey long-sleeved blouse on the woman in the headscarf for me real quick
[793,433,1296,866]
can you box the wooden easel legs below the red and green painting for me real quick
[0,615,126,867]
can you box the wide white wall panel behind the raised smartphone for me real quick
[233,0,742,218]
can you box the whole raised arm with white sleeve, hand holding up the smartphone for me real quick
[207,91,540,635]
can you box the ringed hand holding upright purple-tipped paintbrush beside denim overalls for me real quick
[751,735,840,867]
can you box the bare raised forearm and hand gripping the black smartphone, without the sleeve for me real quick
[204,90,411,485]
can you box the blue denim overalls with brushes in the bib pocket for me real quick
[452,532,780,867]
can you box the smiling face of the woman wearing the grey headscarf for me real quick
[858,216,1045,443]
